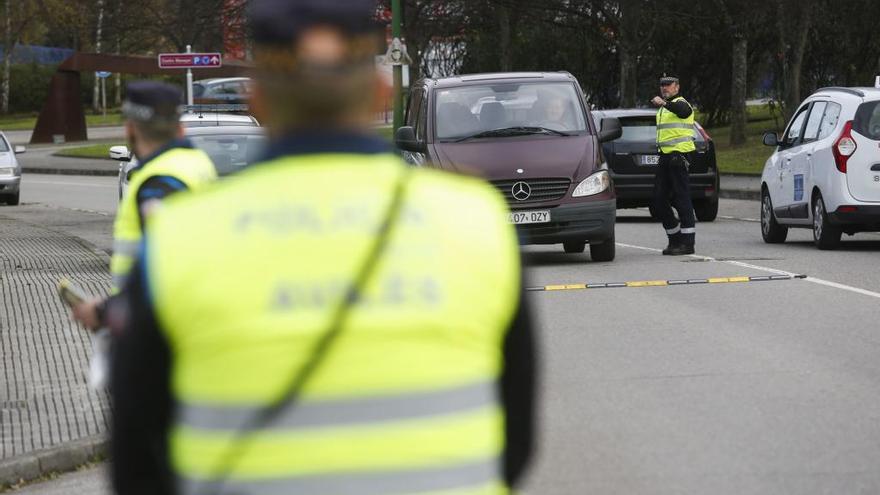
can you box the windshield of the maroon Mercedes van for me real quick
[435,82,587,140]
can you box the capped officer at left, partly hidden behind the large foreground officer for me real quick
[73,81,217,330]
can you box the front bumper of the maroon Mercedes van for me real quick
[517,199,617,244]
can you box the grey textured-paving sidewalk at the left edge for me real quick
[0,206,110,489]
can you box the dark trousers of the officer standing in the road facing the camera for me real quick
[654,152,697,246]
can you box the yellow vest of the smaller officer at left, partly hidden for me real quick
[110,148,217,292]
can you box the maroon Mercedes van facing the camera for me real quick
[395,72,621,261]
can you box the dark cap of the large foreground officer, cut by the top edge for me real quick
[250,0,377,44]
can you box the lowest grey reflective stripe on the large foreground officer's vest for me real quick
[180,458,504,495]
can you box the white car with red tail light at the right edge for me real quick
[761,88,880,249]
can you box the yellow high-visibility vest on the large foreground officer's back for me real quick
[146,154,521,495]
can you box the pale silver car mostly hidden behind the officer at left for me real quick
[110,125,266,200]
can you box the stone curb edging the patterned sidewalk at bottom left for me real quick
[0,436,110,491]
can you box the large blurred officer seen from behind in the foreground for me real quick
[112,0,534,495]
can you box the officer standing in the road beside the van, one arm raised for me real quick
[652,76,697,256]
